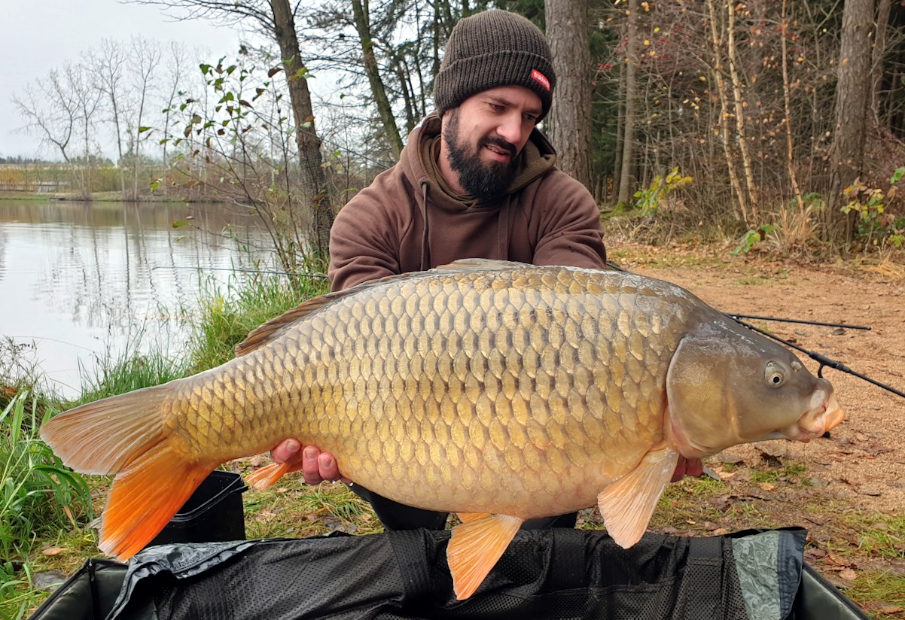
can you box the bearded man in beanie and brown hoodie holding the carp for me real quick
[272,10,700,529]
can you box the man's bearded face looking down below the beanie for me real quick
[440,86,542,200]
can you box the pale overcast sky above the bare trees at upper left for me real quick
[0,0,247,158]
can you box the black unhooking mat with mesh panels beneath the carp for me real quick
[32,528,866,620]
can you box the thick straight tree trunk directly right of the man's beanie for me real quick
[545,0,591,189]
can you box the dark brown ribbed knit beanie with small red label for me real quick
[434,10,556,120]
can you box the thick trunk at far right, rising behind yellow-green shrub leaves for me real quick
[825,0,874,243]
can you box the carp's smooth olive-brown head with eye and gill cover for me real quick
[666,316,832,457]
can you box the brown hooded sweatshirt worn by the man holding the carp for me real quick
[329,114,606,291]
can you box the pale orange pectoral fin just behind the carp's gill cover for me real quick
[597,447,679,549]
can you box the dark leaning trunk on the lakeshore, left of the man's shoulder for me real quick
[270,0,333,260]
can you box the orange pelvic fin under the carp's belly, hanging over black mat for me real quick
[446,515,523,601]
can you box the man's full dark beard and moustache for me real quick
[443,108,516,202]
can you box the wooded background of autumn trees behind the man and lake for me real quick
[7,0,905,271]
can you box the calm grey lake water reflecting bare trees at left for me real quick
[0,200,276,397]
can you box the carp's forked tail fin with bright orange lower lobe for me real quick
[41,385,217,560]
